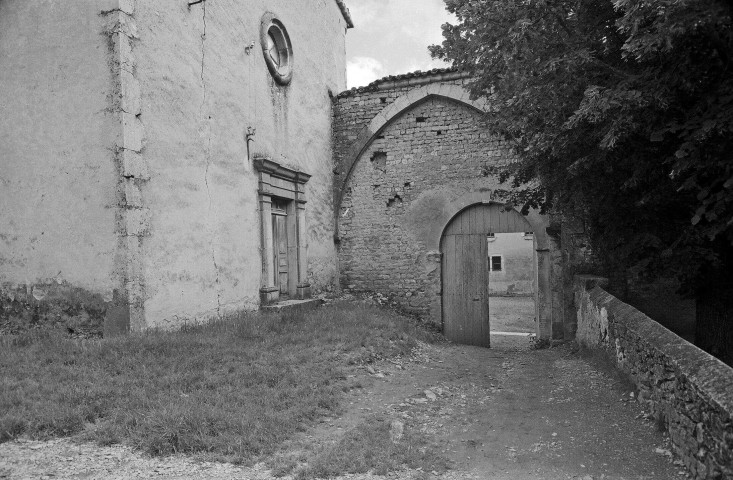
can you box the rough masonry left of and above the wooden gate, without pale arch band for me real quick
[334,79,511,321]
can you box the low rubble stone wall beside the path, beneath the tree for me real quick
[575,276,733,479]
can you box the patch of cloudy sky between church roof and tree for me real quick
[346,0,455,88]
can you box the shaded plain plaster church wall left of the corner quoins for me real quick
[0,0,121,338]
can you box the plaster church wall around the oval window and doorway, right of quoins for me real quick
[134,0,346,326]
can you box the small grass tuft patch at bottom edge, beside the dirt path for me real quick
[288,415,449,480]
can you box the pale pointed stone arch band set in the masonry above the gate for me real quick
[334,83,487,214]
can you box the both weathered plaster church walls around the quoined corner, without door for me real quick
[0,0,350,333]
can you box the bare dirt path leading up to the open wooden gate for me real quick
[334,337,686,479]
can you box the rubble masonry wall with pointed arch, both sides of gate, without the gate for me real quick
[333,79,574,339]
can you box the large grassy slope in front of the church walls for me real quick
[0,303,430,463]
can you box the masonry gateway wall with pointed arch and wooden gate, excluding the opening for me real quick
[334,70,572,346]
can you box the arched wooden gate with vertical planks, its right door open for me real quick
[441,204,531,347]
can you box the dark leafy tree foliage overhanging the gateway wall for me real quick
[430,0,733,286]
